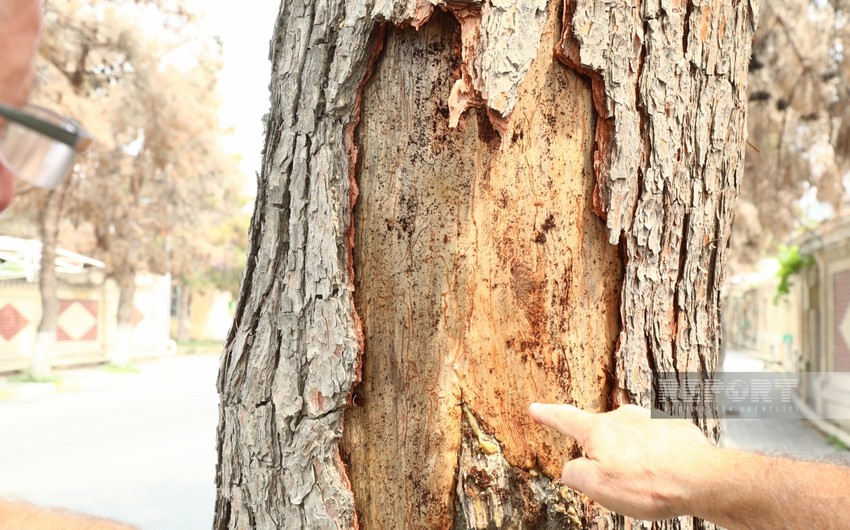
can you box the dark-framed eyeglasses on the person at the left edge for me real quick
[0,104,92,188]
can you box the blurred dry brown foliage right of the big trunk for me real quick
[733,0,850,263]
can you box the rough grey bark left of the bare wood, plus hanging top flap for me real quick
[215,0,568,528]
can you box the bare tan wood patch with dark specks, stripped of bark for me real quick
[344,9,622,528]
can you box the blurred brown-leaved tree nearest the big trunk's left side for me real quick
[61,24,242,364]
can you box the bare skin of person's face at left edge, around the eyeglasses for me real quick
[0,0,41,211]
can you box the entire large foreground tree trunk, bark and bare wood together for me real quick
[215,0,758,529]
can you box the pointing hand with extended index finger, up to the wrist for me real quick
[529,403,720,520]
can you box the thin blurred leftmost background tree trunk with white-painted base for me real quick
[29,186,69,378]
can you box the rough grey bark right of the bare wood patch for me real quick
[559,0,759,416]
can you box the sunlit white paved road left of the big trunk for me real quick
[0,355,218,530]
